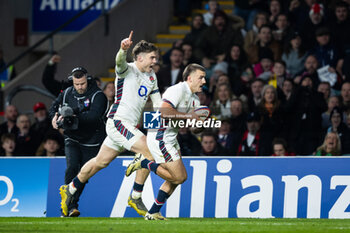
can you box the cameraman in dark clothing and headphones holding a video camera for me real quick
[49,67,108,217]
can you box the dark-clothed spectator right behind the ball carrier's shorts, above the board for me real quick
[177,128,201,156]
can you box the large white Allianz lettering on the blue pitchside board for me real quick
[110,159,350,218]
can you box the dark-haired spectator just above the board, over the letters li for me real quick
[200,131,227,156]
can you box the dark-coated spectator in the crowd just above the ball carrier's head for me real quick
[195,10,243,68]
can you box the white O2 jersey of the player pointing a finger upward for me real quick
[107,62,161,126]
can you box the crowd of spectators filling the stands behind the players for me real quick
[0,0,350,156]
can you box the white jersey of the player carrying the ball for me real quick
[147,82,200,144]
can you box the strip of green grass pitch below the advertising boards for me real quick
[0,217,350,233]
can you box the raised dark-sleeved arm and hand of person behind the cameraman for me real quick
[41,54,71,96]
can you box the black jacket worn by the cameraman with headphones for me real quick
[49,81,108,145]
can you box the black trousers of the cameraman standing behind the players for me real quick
[64,139,100,210]
